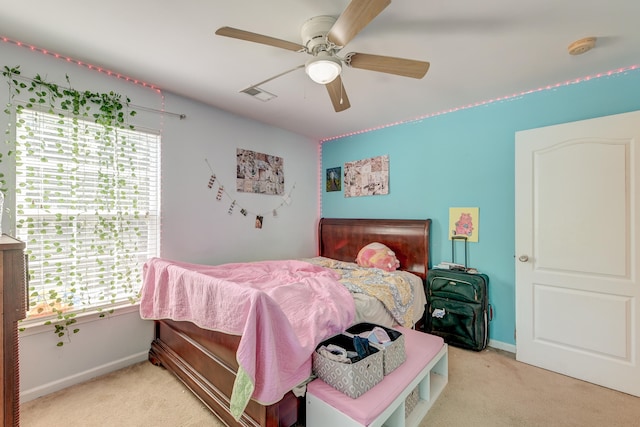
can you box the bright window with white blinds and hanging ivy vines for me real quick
[16,108,160,320]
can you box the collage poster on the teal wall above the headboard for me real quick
[344,155,389,197]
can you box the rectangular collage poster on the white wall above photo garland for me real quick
[236,148,284,195]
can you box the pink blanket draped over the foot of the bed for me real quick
[140,258,355,418]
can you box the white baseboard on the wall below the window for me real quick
[20,351,149,403]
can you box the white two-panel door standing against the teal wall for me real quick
[515,111,640,396]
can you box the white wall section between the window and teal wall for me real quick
[162,94,318,263]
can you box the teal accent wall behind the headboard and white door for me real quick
[320,67,640,344]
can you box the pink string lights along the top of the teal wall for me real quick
[319,64,640,145]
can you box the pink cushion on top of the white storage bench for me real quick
[307,326,444,426]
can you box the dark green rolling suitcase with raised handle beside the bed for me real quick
[424,236,491,351]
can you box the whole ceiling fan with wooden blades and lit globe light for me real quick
[216,0,429,112]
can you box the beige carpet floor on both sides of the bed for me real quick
[21,347,640,427]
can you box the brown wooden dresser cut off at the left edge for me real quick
[0,234,26,427]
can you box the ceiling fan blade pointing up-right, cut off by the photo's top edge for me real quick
[327,0,391,46]
